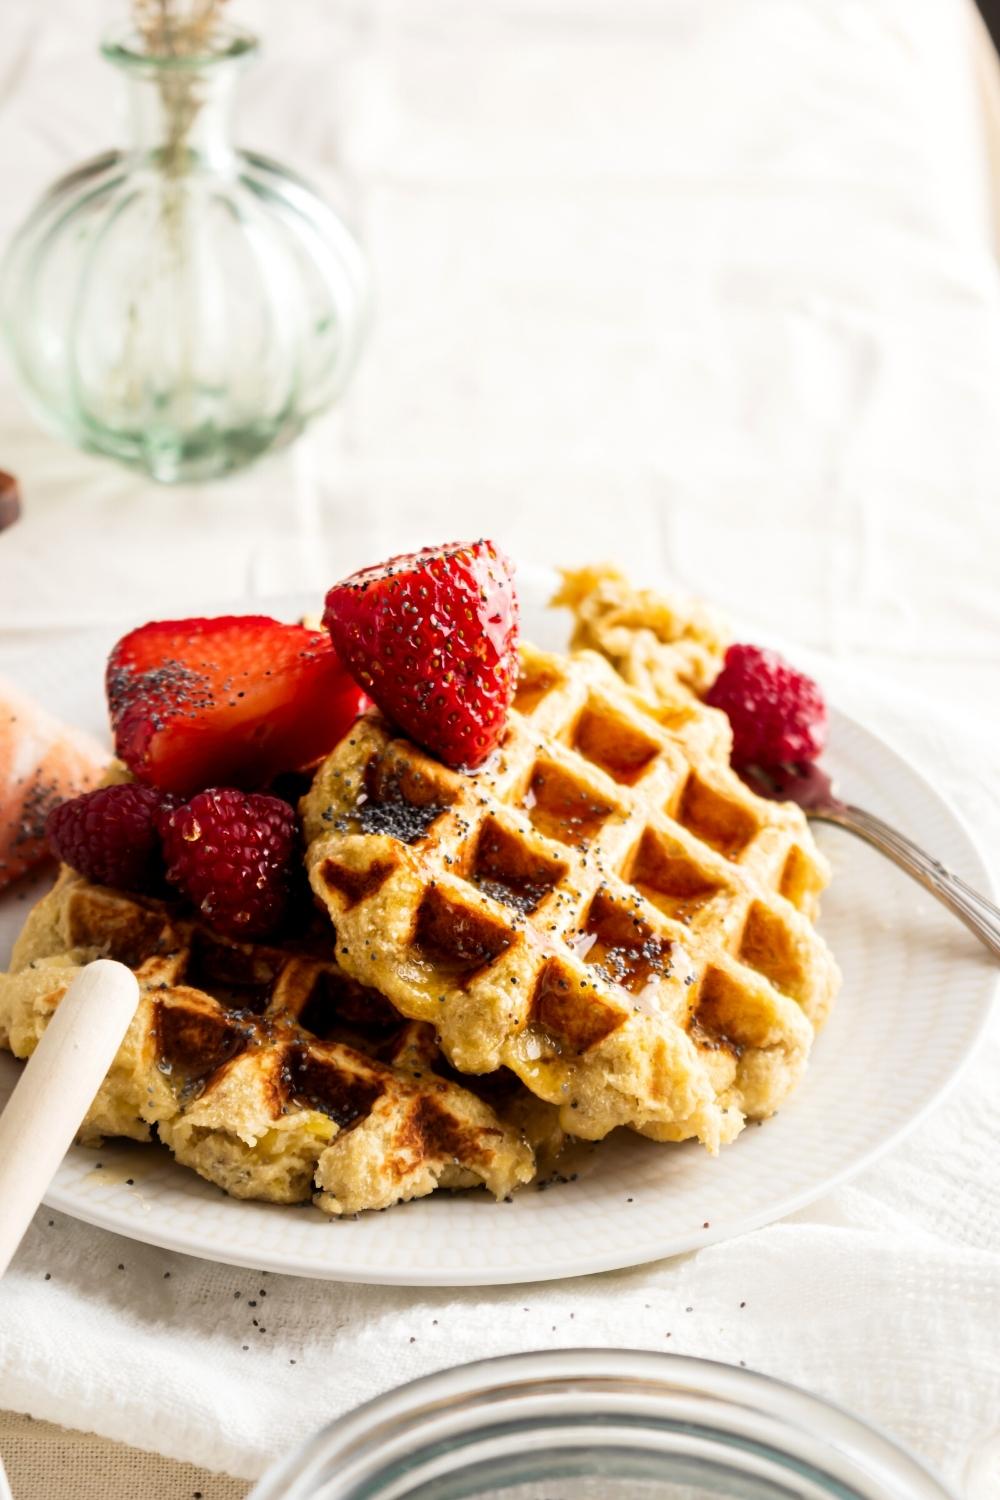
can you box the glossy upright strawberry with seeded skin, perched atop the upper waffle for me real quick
[322,542,517,768]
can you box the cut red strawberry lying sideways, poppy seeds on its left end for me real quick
[106,615,367,795]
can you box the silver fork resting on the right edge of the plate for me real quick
[741,765,1000,959]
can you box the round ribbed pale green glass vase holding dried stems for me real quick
[0,29,367,482]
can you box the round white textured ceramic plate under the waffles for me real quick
[0,570,997,1286]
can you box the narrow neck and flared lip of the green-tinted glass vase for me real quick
[102,32,256,174]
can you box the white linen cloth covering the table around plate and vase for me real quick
[0,0,1000,1500]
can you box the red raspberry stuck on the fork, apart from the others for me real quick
[706,645,826,767]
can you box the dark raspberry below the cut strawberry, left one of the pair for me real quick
[45,783,163,893]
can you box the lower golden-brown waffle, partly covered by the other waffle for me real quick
[0,870,539,1214]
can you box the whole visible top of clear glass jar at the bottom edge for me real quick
[250,1350,954,1500]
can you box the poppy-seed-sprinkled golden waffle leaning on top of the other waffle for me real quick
[301,647,838,1151]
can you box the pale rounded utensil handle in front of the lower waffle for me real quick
[0,959,139,1277]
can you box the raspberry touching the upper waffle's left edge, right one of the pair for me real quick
[157,786,298,938]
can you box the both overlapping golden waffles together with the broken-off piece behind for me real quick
[0,573,837,1215]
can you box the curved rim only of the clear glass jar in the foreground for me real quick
[250,1349,954,1500]
